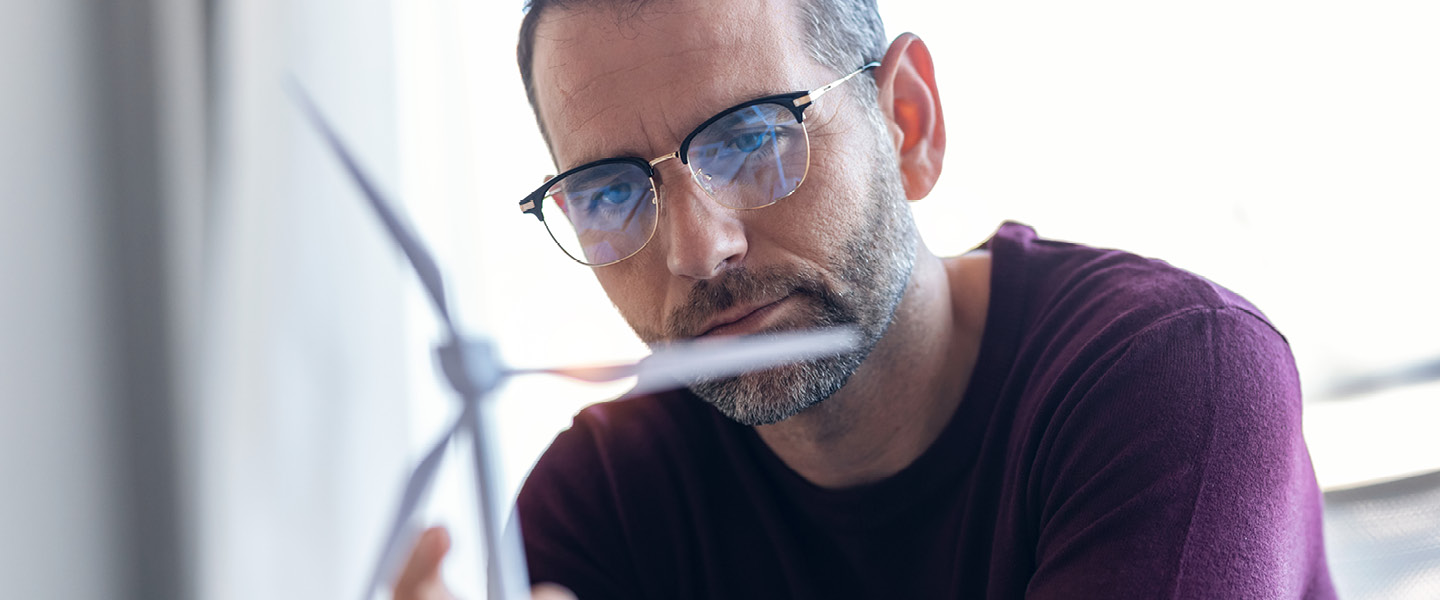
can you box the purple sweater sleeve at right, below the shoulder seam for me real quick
[1027,308,1335,599]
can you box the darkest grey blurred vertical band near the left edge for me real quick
[88,0,202,599]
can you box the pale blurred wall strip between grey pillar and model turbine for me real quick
[195,0,425,600]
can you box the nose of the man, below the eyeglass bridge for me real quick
[658,161,749,279]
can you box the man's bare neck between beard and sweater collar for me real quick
[756,243,989,488]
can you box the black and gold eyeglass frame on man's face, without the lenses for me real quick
[520,60,880,266]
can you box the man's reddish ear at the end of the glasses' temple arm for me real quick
[876,33,945,200]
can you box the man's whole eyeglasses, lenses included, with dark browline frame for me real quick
[520,62,880,266]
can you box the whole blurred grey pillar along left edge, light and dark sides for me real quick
[0,0,204,599]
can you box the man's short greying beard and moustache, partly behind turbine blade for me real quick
[687,156,917,426]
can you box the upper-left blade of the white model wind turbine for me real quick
[289,82,455,332]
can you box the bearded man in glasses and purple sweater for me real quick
[397,0,1333,592]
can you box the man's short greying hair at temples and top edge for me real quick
[516,0,887,153]
